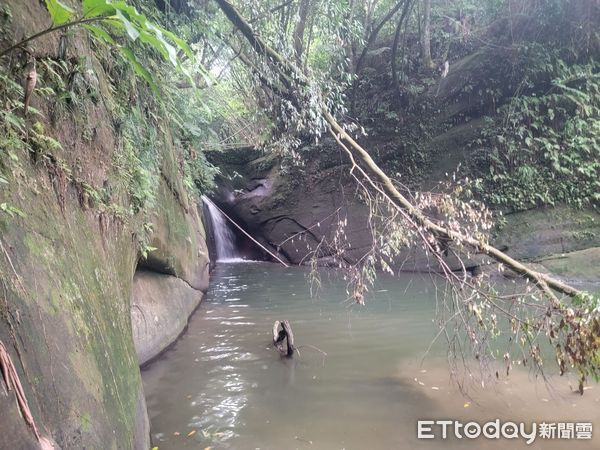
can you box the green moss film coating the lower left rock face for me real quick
[1,171,140,447]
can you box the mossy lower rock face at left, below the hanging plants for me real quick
[0,163,141,448]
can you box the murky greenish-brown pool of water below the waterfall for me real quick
[142,263,600,450]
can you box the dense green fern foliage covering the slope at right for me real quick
[475,59,600,209]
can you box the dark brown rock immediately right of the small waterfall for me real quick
[209,148,370,265]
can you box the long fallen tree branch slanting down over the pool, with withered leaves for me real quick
[215,0,600,382]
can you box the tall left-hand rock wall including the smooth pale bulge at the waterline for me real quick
[0,0,208,449]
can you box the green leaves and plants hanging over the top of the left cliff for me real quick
[0,0,218,220]
